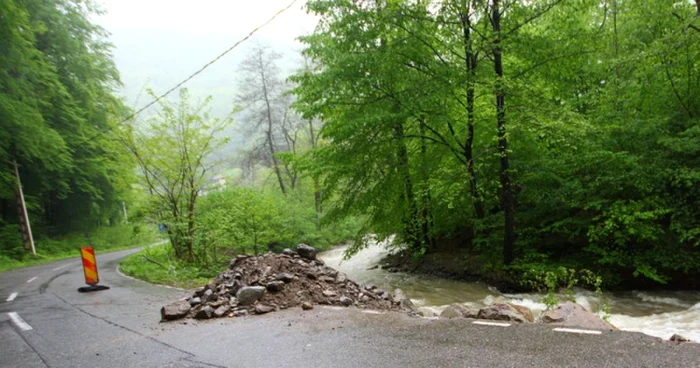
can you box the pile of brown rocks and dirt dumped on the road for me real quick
[161,244,415,320]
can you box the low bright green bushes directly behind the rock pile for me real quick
[197,188,359,263]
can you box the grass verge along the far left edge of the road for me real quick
[0,225,159,272]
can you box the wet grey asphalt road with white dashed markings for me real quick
[0,250,700,368]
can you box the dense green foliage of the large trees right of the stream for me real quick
[292,0,700,289]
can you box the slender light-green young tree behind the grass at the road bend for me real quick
[117,89,233,262]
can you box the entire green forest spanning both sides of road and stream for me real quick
[0,0,700,288]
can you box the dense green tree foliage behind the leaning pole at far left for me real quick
[0,0,133,252]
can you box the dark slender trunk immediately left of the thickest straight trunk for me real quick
[460,1,484,219]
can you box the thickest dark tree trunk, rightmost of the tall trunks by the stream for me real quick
[491,0,515,265]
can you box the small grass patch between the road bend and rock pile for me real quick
[119,246,225,289]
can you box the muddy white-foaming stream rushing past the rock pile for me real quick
[319,244,700,342]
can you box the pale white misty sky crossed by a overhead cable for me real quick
[95,0,316,113]
